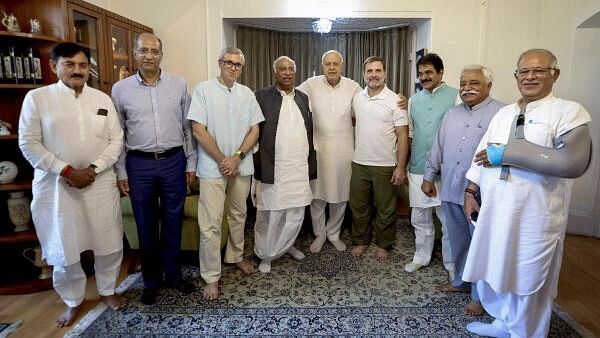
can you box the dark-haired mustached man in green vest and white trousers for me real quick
[404,53,458,279]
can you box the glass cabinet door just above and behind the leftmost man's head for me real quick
[69,7,104,90]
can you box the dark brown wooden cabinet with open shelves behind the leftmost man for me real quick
[0,0,152,294]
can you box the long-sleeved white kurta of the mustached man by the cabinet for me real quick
[19,81,123,266]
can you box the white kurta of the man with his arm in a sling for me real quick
[463,95,590,295]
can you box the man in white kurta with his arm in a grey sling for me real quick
[463,50,590,337]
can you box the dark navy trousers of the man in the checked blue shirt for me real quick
[126,150,187,288]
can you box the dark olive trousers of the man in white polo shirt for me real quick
[349,162,398,250]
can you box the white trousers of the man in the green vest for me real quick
[410,206,454,270]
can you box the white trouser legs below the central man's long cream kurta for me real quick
[310,199,348,242]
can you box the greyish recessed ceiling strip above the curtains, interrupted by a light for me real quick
[224,18,429,32]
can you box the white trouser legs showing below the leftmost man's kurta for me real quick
[52,250,123,307]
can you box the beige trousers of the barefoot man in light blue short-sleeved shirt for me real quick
[198,176,251,283]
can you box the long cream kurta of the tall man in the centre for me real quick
[297,75,360,203]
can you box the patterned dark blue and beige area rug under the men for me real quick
[68,219,581,338]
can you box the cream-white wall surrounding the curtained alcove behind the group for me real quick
[92,0,600,235]
